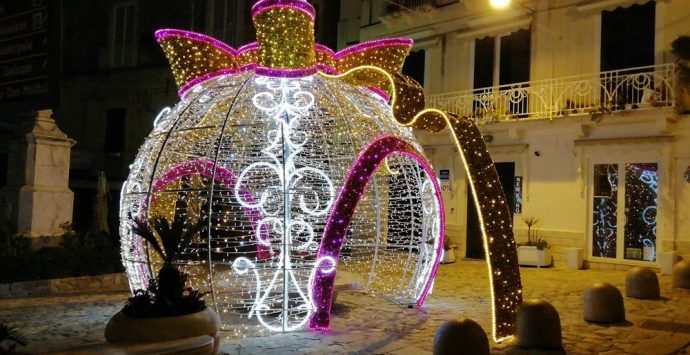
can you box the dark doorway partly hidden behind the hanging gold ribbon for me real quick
[465,162,515,259]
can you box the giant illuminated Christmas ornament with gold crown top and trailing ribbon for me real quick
[120,0,521,339]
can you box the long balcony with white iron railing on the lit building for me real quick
[427,64,675,124]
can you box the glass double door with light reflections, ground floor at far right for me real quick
[590,162,658,262]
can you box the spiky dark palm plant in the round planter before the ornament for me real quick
[122,218,206,317]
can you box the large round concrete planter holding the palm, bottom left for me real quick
[105,307,221,354]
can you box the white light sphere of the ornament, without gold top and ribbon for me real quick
[120,71,443,335]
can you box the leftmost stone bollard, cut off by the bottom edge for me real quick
[434,318,491,355]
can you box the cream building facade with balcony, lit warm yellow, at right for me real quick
[338,0,690,268]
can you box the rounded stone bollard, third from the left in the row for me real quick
[583,283,625,323]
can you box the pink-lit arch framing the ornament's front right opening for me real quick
[309,135,445,329]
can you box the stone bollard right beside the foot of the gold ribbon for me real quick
[516,299,563,349]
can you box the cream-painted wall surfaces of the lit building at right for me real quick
[341,0,690,267]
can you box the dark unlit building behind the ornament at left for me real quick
[0,0,340,232]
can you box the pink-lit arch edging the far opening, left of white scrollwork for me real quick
[142,160,273,259]
